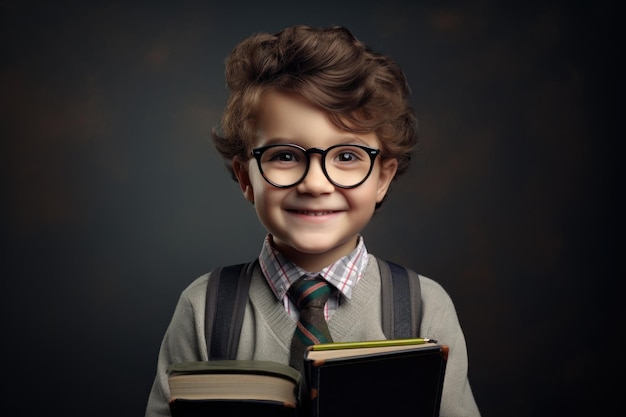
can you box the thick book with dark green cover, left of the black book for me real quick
[167,360,302,417]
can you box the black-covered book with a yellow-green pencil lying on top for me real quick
[304,339,449,417]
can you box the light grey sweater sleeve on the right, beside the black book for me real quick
[420,276,480,417]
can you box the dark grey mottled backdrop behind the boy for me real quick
[0,0,624,417]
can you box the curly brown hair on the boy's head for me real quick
[213,25,417,187]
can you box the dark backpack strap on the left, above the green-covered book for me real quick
[204,260,258,360]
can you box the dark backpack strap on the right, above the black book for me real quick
[378,259,422,339]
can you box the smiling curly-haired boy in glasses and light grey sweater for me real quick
[146,26,479,417]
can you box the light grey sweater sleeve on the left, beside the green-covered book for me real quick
[145,275,208,417]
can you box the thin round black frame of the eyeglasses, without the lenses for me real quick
[251,143,380,189]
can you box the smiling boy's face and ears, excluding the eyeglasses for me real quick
[233,92,397,271]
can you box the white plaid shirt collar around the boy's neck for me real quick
[259,235,369,320]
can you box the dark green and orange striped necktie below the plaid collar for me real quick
[289,275,332,372]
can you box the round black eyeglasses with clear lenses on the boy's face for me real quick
[252,144,380,188]
